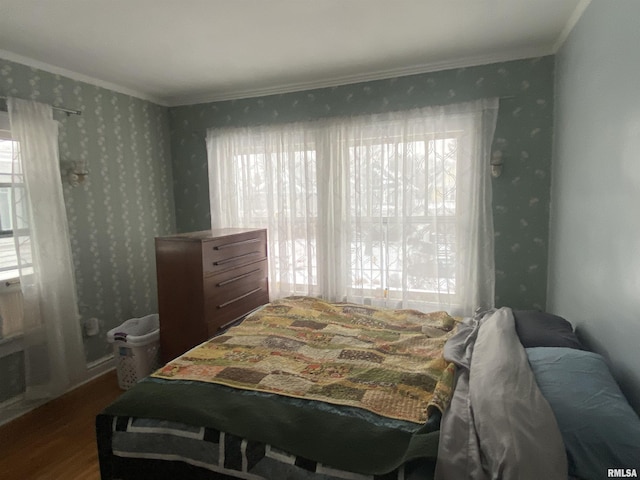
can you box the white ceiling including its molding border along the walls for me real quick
[0,0,590,105]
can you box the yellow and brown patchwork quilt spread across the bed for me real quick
[153,297,457,424]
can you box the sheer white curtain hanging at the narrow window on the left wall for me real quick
[7,98,86,400]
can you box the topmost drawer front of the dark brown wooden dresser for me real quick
[202,230,267,273]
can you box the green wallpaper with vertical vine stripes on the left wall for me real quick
[0,59,175,362]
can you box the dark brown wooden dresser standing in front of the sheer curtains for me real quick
[156,228,269,362]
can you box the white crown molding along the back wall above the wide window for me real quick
[165,47,554,107]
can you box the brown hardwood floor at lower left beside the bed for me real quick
[0,371,122,480]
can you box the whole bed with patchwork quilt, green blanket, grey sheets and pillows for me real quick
[96,297,640,480]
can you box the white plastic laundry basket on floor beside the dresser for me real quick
[107,313,160,390]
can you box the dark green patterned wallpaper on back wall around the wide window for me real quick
[169,56,554,309]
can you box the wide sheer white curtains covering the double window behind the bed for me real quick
[207,99,498,314]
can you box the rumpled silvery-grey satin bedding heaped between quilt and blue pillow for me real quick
[436,308,567,480]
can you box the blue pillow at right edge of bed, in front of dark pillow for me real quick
[526,347,640,480]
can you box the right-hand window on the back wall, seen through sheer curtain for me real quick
[349,135,458,298]
